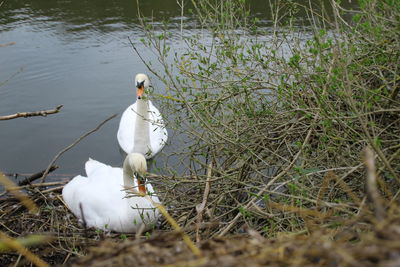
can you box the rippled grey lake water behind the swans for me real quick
[0,0,356,180]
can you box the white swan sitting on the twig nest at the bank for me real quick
[62,153,160,233]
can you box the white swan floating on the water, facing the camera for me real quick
[117,73,168,159]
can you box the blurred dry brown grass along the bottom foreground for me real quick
[72,216,400,266]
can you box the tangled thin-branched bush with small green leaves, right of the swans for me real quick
[140,0,400,238]
